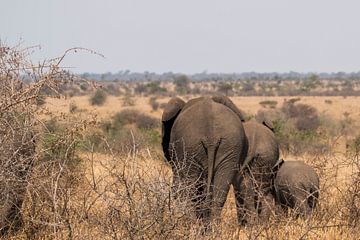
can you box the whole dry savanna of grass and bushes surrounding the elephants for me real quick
[0,44,360,239]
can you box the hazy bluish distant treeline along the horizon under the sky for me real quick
[81,70,360,82]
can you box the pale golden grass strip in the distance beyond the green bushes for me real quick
[46,96,360,123]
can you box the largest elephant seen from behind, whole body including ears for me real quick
[162,96,248,226]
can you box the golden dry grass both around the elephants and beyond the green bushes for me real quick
[23,94,359,239]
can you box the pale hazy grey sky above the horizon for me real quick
[0,0,360,73]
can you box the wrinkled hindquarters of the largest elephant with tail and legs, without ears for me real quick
[170,98,247,223]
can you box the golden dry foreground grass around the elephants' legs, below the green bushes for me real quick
[7,147,359,239]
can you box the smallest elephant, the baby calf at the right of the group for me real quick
[273,161,319,218]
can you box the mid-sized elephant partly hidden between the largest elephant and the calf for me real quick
[234,119,279,225]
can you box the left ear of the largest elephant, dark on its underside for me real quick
[161,97,185,161]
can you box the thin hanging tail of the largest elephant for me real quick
[202,138,221,201]
